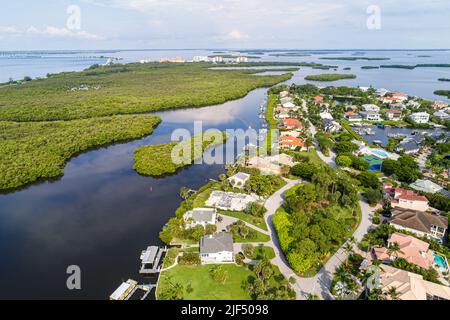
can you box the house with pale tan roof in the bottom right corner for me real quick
[379,266,450,301]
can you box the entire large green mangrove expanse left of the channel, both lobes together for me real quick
[0,63,292,190]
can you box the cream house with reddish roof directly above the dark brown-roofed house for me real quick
[383,183,430,211]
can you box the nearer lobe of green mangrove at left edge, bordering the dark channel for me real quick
[0,115,160,190]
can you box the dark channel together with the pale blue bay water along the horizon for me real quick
[0,50,450,299]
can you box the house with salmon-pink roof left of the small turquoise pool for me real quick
[373,232,434,270]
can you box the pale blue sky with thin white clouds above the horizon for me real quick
[0,0,450,50]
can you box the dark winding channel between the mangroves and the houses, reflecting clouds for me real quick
[0,89,267,299]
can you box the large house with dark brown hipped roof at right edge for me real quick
[389,208,448,242]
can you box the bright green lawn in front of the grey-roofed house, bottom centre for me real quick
[157,264,255,300]
